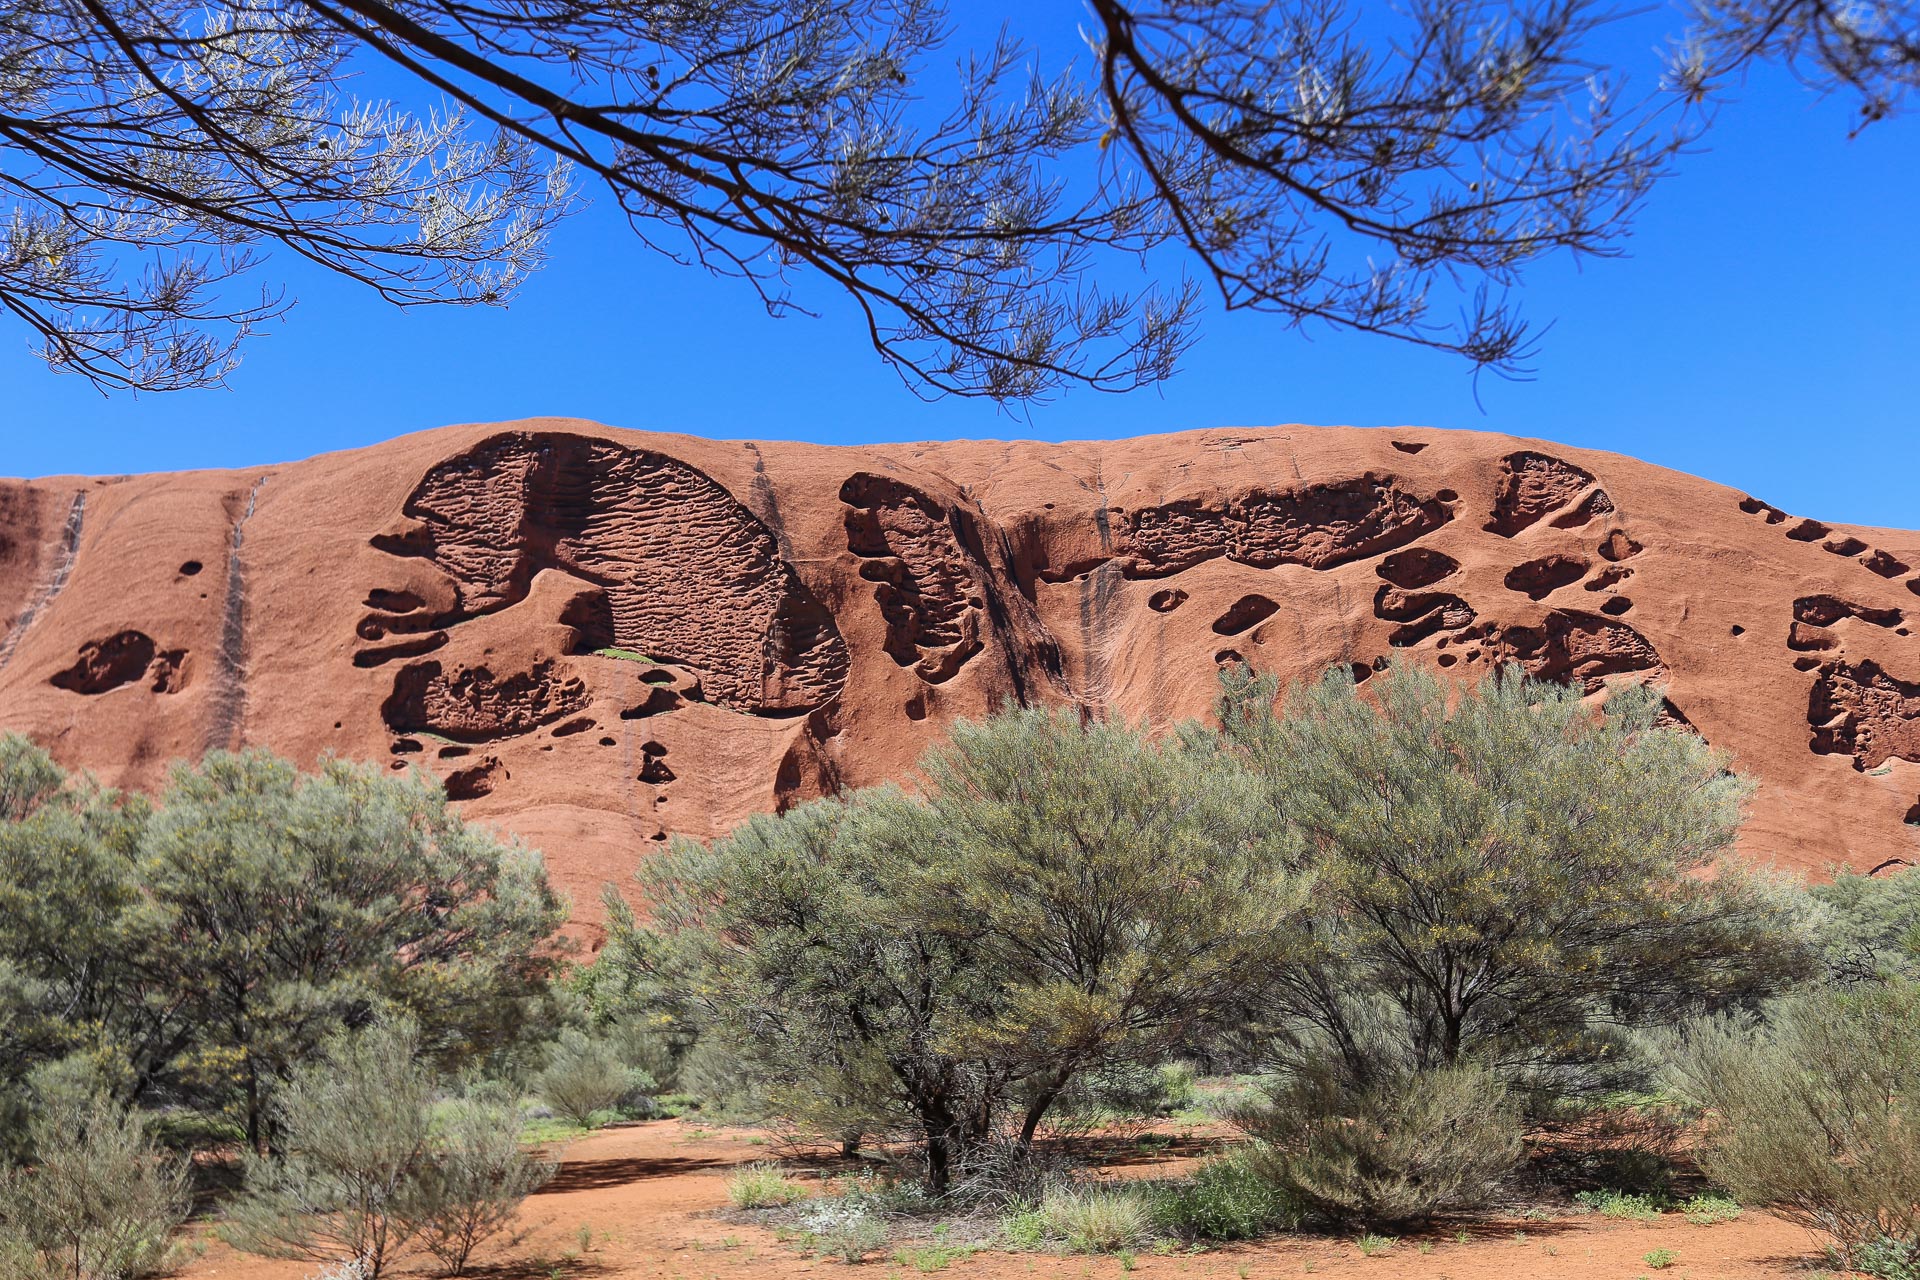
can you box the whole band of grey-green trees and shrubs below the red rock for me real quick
[0,652,1920,1280]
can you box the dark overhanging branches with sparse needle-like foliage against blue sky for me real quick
[0,0,1920,401]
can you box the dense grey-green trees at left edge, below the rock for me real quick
[0,743,566,1150]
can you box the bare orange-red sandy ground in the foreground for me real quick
[182,1121,1818,1280]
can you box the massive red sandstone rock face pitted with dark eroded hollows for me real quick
[0,420,1920,932]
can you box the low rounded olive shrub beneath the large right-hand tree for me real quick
[1236,1067,1521,1222]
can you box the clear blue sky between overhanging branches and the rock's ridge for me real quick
[0,20,1920,528]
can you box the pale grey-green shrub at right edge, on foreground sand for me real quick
[1670,979,1920,1261]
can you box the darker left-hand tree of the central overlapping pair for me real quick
[629,800,1016,1190]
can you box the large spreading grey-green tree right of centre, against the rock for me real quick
[1221,666,1811,1090]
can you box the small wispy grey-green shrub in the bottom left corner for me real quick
[0,1094,190,1280]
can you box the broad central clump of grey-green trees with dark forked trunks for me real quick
[609,710,1300,1192]
